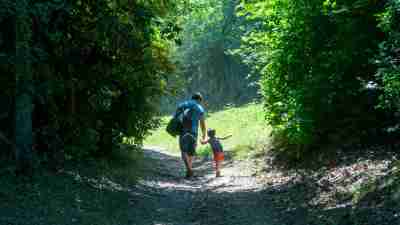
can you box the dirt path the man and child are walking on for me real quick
[130,149,275,225]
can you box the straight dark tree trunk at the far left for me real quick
[15,0,33,174]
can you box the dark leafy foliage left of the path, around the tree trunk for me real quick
[0,0,181,162]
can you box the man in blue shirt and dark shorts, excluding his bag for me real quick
[178,93,207,178]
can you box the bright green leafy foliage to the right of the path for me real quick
[238,0,394,158]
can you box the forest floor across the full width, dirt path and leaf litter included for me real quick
[0,143,400,225]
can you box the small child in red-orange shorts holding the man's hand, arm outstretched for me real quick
[201,129,232,177]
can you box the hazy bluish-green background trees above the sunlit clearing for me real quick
[175,0,257,107]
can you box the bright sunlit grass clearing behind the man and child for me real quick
[145,103,269,159]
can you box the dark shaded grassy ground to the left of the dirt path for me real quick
[0,148,143,225]
